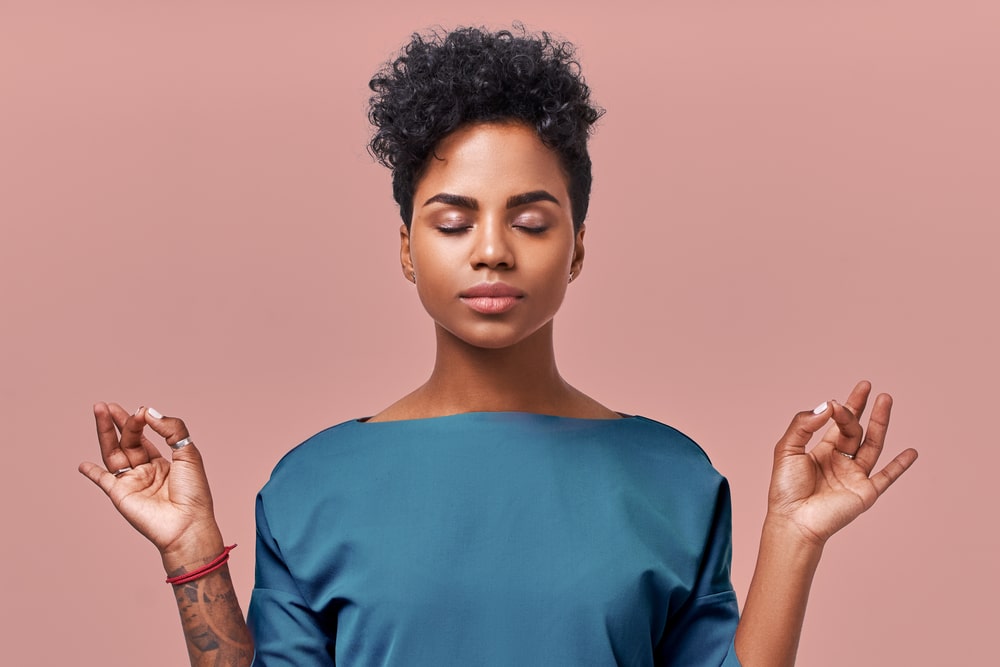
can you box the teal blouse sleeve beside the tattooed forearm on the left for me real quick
[247,495,335,667]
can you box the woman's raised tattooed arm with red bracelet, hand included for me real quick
[80,403,253,667]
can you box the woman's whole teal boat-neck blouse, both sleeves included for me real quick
[248,412,739,667]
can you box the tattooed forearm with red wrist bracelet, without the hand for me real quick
[163,536,253,667]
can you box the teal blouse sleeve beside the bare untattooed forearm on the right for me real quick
[655,479,741,667]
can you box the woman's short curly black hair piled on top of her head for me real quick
[368,24,604,229]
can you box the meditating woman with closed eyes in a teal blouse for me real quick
[80,29,916,667]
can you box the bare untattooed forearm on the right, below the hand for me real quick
[736,518,823,667]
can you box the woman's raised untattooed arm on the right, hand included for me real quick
[735,382,917,667]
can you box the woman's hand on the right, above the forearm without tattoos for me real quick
[768,381,917,546]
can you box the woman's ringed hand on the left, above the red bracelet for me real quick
[79,403,223,572]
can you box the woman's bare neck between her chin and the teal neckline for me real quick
[419,321,574,414]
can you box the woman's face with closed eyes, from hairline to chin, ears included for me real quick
[400,123,583,348]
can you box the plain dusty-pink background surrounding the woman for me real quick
[0,0,1000,667]
